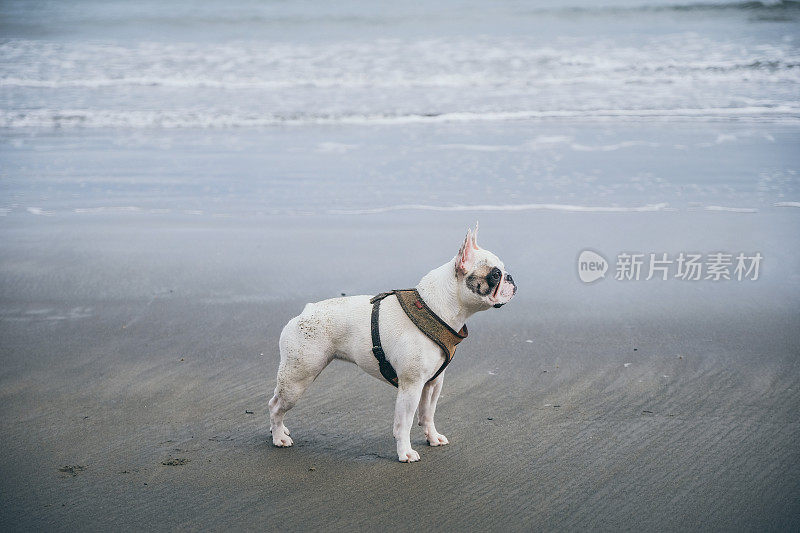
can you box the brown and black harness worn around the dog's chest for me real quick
[370,289,468,387]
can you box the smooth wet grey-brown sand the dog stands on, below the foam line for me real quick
[0,210,800,531]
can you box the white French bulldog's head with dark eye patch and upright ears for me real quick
[454,224,517,310]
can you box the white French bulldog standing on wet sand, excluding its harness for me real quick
[269,225,517,462]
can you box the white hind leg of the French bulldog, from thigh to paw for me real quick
[269,315,333,447]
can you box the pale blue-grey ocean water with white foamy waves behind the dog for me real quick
[0,0,800,216]
